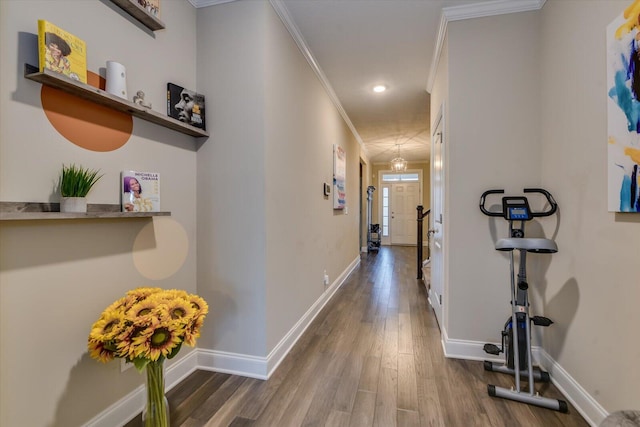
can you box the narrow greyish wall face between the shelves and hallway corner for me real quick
[197,2,269,356]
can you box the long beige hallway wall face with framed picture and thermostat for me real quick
[264,2,360,352]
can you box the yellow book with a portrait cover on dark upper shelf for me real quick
[38,19,87,83]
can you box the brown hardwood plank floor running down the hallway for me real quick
[126,247,588,427]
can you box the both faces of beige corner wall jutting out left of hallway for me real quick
[197,2,360,357]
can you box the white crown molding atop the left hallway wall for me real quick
[269,0,368,153]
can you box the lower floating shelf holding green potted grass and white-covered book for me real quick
[0,202,171,221]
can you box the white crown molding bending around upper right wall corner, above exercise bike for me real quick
[427,0,546,93]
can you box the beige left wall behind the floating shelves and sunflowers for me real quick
[0,0,196,427]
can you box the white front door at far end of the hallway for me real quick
[391,182,420,245]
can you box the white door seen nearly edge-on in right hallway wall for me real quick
[429,107,445,329]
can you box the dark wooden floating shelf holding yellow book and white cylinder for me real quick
[24,64,209,137]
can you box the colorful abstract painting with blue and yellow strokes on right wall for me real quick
[607,0,640,212]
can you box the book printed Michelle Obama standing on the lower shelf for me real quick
[120,170,160,212]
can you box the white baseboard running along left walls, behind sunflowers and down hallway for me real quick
[83,255,360,427]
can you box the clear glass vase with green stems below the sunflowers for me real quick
[142,361,170,427]
